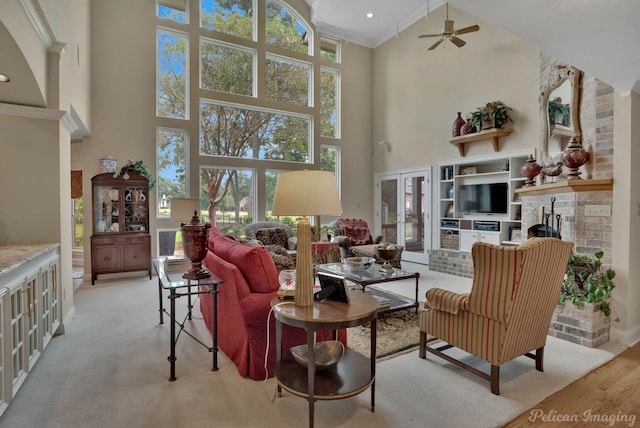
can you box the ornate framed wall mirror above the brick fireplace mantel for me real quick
[540,65,582,164]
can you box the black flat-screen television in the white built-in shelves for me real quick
[456,183,509,214]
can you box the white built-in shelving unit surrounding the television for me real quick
[437,154,527,251]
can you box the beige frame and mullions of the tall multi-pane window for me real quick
[156,0,344,232]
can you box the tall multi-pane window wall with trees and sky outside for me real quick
[156,0,342,234]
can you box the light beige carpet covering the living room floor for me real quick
[0,264,623,428]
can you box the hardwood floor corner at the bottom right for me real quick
[503,344,640,428]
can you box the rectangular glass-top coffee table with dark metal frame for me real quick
[314,263,420,313]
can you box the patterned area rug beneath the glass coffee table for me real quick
[347,308,420,359]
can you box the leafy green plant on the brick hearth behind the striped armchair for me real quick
[560,251,618,321]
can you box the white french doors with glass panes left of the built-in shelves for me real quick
[375,169,431,264]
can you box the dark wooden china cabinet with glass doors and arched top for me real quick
[91,171,151,284]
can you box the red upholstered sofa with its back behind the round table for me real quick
[200,227,346,380]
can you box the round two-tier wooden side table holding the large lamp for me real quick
[271,293,378,427]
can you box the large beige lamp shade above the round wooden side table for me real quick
[271,170,342,216]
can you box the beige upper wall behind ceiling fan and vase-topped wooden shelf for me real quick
[373,3,540,172]
